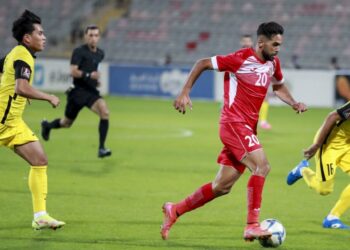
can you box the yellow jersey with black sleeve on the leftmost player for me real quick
[0,44,35,127]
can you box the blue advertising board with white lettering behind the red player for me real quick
[109,65,214,99]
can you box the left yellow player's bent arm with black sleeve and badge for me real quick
[14,61,60,107]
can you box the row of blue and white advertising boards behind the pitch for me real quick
[34,59,336,107]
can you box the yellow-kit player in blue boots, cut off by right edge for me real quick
[287,102,350,229]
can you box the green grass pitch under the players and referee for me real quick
[0,95,350,250]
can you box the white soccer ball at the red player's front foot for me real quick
[259,219,287,247]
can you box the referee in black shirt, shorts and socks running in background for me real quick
[41,25,112,158]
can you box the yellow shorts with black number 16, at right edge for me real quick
[315,130,350,182]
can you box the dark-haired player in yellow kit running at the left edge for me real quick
[0,10,65,230]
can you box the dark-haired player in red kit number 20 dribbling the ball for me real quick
[161,22,307,241]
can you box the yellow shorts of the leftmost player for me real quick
[0,121,39,149]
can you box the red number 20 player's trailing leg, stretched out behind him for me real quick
[161,165,241,240]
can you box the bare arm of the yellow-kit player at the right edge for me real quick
[304,111,342,159]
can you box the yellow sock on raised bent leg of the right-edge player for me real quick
[301,168,334,195]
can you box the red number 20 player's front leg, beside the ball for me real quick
[241,148,271,241]
